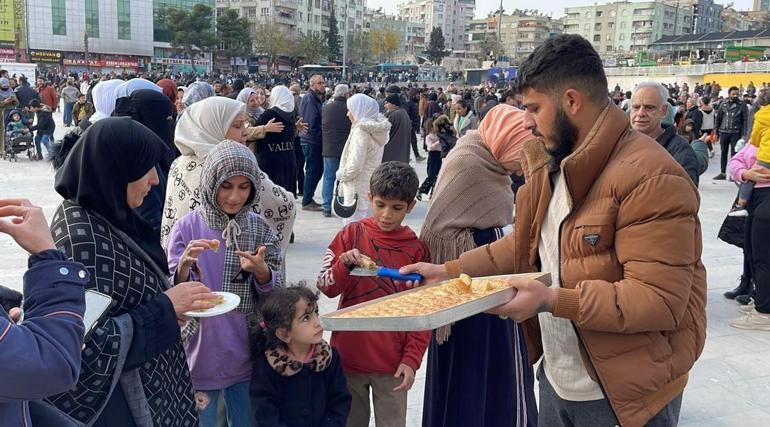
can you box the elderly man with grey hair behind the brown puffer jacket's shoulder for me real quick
[631,82,702,187]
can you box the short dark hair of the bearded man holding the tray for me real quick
[516,34,607,102]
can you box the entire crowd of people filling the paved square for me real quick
[0,35,770,427]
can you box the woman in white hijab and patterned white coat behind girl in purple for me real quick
[160,96,296,260]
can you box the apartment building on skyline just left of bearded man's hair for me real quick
[465,11,563,62]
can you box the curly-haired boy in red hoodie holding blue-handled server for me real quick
[318,162,431,427]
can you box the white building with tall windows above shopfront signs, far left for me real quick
[25,0,153,72]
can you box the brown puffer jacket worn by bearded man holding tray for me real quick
[446,104,706,426]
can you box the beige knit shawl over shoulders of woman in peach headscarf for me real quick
[420,131,514,264]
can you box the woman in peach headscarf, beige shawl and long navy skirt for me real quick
[420,104,537,427]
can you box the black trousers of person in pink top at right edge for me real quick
[744,187,770,314]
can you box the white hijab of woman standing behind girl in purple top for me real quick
[174,96,246,159]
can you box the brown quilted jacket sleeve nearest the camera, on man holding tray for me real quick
[553,174,704,333]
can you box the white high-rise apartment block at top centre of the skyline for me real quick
[398,0,476,50]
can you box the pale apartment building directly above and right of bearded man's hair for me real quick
[564,1,693,56]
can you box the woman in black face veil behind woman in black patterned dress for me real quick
[112,89,177,235]
